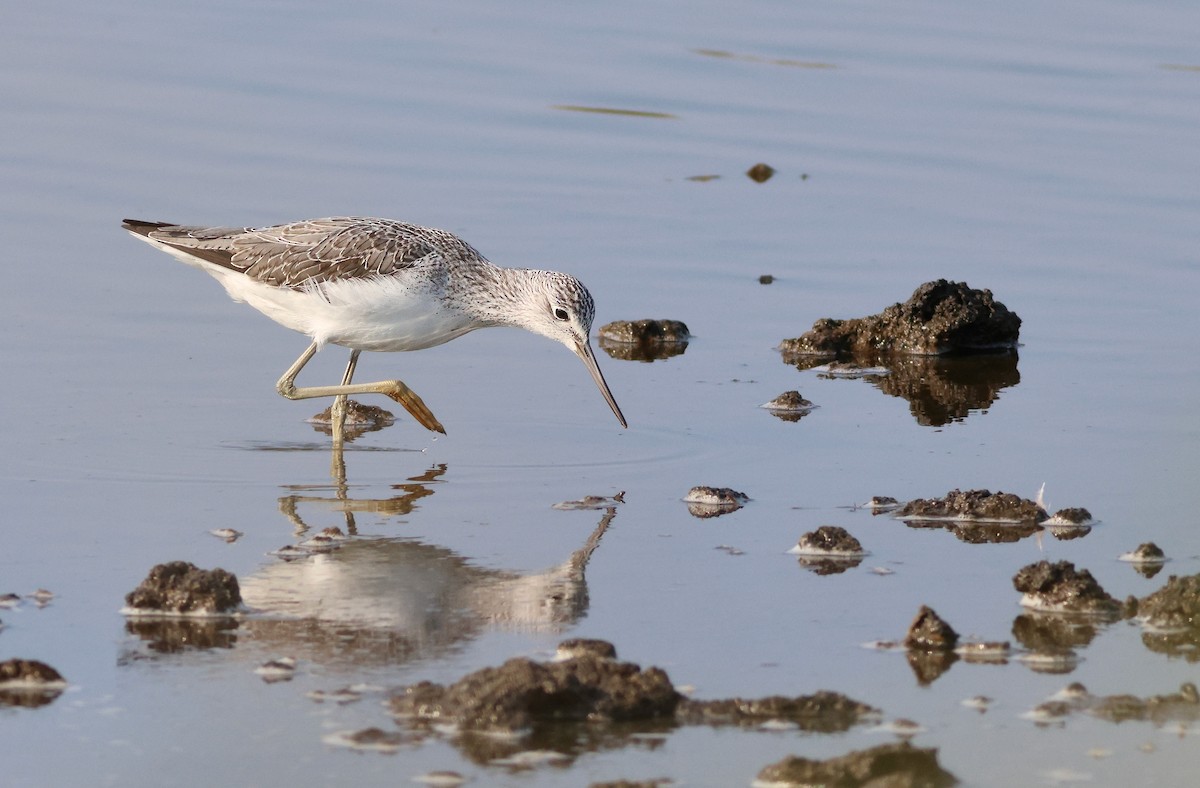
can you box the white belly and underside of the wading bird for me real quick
[206,266,479,351]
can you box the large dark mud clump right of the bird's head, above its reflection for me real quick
[780,279,1021,357]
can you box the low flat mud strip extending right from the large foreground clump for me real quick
[678,691,880,733]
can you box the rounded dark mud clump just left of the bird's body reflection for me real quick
[125,561,241,615]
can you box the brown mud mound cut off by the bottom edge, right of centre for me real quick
[755,741,958,788]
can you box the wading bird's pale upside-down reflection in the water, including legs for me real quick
[239,465,617,668]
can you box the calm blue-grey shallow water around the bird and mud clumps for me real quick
[0,1,1200,786]
